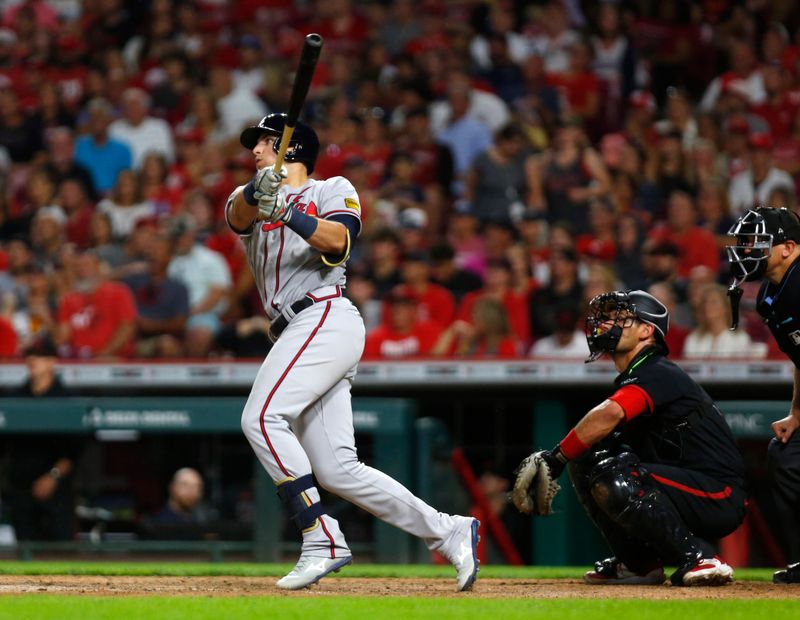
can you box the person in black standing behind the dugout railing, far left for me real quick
[3,338,82,541]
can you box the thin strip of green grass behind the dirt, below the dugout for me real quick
[0,561,774,581]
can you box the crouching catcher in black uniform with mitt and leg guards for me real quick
[512,290,746,586]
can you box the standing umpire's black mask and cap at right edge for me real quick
[727,207,800,329]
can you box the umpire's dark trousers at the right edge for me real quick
[767,431,800,564]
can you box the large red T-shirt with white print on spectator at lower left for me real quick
[58,282,136,357]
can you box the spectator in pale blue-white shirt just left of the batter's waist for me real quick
[167,213,231,357]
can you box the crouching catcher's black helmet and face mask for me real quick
[585,290,669,364]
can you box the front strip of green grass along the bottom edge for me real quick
[0,595,798,620]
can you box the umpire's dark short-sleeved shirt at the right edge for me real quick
[756,259,800,368]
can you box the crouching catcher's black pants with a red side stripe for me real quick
[569,450,747,571]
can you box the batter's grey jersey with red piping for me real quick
[225,177,361,320]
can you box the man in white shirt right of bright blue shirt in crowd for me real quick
[108,88,175,170]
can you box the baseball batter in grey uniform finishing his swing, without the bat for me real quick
[225,114,479,591]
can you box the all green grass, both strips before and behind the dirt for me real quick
[0,561,800,620]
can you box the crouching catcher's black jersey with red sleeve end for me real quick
[609,346,744,489]
